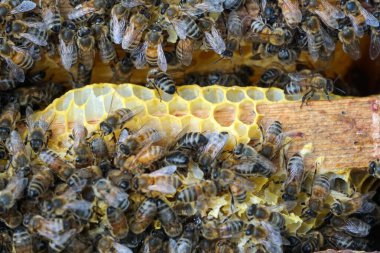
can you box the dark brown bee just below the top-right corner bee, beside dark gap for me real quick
[338,26,361,60]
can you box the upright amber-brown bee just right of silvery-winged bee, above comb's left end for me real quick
[76,26,95,70]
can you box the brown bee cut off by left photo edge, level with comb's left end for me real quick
[0,103,21,143]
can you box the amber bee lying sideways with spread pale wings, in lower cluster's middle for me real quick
[132,166,182,194]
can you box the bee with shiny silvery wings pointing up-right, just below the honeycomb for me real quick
[198,132,229,166]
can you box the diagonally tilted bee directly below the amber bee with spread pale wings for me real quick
[130,198,157,234]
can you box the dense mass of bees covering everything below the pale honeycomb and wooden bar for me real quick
[0,97,380,253]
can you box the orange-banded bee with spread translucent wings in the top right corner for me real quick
[343,0,380,38]
